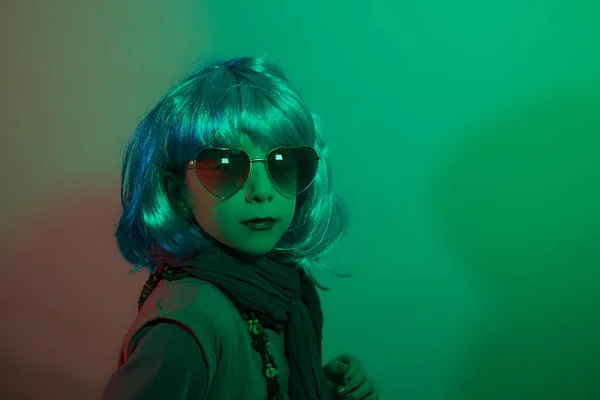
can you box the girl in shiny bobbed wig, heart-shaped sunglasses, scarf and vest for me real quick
[104,58,378,400]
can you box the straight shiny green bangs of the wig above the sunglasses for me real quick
[166,65,315,167]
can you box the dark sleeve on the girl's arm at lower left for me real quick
[102,321,208,400]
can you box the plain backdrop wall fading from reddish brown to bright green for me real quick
[0,0,600,400]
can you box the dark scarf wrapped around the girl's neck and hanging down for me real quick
[150,246,331,400]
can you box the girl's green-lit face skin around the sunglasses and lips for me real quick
[185,134,296,255]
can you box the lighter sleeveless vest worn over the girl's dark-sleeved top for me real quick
[118,278,289,400]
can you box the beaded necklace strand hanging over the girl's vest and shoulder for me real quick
[138,264,283,400]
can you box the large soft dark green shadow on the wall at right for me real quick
[431,88,600,400]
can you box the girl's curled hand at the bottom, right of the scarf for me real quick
[323,355,379,400]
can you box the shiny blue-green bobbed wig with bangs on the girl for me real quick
[116,57,348,288]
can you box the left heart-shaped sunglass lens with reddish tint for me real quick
[196,149,250,197]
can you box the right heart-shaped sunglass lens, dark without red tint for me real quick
[267,147,319,195]
